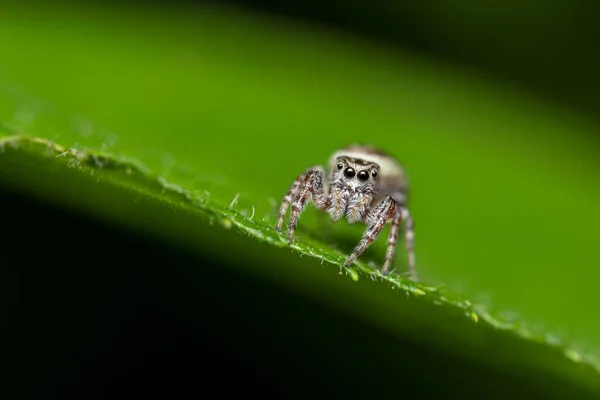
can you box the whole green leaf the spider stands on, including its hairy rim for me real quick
[0,1,600,396]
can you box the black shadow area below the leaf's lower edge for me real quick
[0,183,596,399]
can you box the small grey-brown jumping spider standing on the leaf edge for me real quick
[275,145,417,280]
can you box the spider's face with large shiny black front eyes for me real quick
[331,156,380,190]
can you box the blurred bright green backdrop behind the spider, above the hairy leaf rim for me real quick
[0,1,600,376]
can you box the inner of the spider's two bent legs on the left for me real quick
[278,167,327,243]
